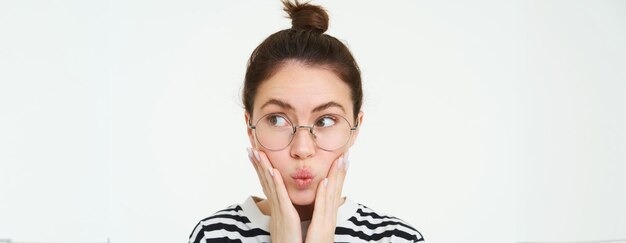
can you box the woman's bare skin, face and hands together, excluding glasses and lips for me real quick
[245,61,363,242]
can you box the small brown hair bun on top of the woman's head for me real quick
[283,0,328,33]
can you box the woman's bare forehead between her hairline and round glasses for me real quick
[254,62,352,113]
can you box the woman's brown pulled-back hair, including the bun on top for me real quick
[242,0,363,121]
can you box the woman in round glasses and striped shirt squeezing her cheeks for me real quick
[189,1,423,243]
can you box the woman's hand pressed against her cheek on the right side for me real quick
[305,152,350,243]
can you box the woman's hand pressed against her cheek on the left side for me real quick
[248,148,302,243]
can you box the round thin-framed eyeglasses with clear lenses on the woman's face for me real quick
[248,113,359,151]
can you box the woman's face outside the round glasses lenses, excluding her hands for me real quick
[246,61,363,205]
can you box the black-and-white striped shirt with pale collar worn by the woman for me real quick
[189,196,424,243]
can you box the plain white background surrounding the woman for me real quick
[0,0,626,243]
